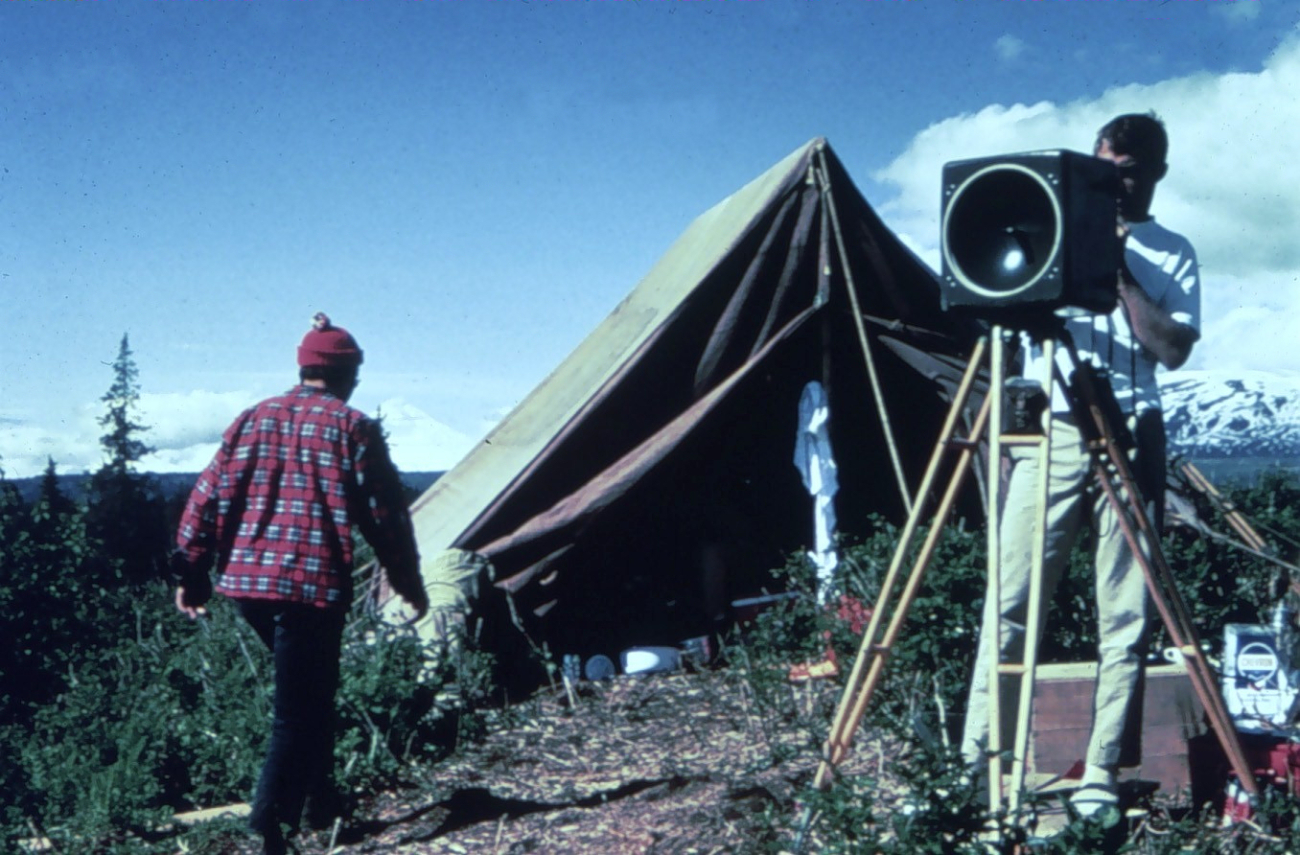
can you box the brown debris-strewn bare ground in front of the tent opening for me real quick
[303,670,881,855]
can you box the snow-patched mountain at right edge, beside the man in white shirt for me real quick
[1160,370,1300,457]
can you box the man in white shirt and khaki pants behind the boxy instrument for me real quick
[962,113,1201,815]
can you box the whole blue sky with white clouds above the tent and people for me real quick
[0,0,1300,477]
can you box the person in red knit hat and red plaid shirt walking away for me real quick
[172,313,429,855]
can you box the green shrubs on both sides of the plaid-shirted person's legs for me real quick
[5,576,475,851]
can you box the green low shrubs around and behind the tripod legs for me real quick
[728,472,1300,855]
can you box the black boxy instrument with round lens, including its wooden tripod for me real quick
[800,151,1258,851]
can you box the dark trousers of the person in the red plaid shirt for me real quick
[239,600,346,834]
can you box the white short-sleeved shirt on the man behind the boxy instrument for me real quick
[1023,218,1201,416]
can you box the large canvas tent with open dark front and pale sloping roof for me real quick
[400,139,970,670]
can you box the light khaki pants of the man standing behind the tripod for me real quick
[962,411,1165,767]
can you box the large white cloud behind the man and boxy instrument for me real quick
[876,25,1300,370]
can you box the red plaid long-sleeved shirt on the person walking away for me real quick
[177,386,421,608]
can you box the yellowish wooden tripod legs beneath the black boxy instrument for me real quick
[814,326,1258,811]
